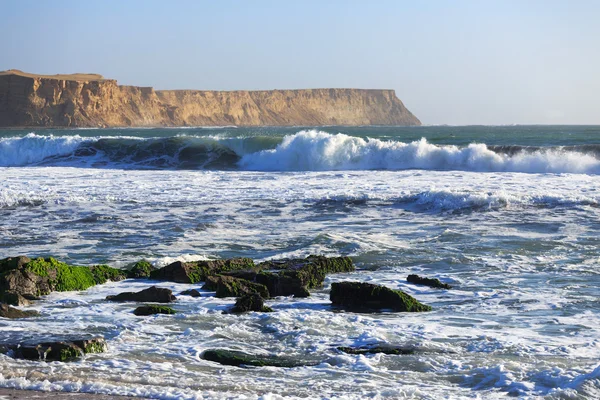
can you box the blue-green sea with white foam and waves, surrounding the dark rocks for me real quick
[0,126,600,399]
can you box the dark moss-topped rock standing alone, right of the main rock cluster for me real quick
[329,282,431,312]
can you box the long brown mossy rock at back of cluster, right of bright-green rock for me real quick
[150,258,254,283]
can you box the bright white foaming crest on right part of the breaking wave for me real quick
[239,130,600,174]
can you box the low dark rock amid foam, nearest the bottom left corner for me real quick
[7,337,107,361]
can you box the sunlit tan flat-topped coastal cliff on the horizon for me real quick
[0,70,421,127]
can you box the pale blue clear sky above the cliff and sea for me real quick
[0,0,600,125]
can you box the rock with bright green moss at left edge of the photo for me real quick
[0,257,125,296]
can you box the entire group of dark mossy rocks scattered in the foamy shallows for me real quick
[0,255,446,367]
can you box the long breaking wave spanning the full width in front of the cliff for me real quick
[0,130,600,174]
